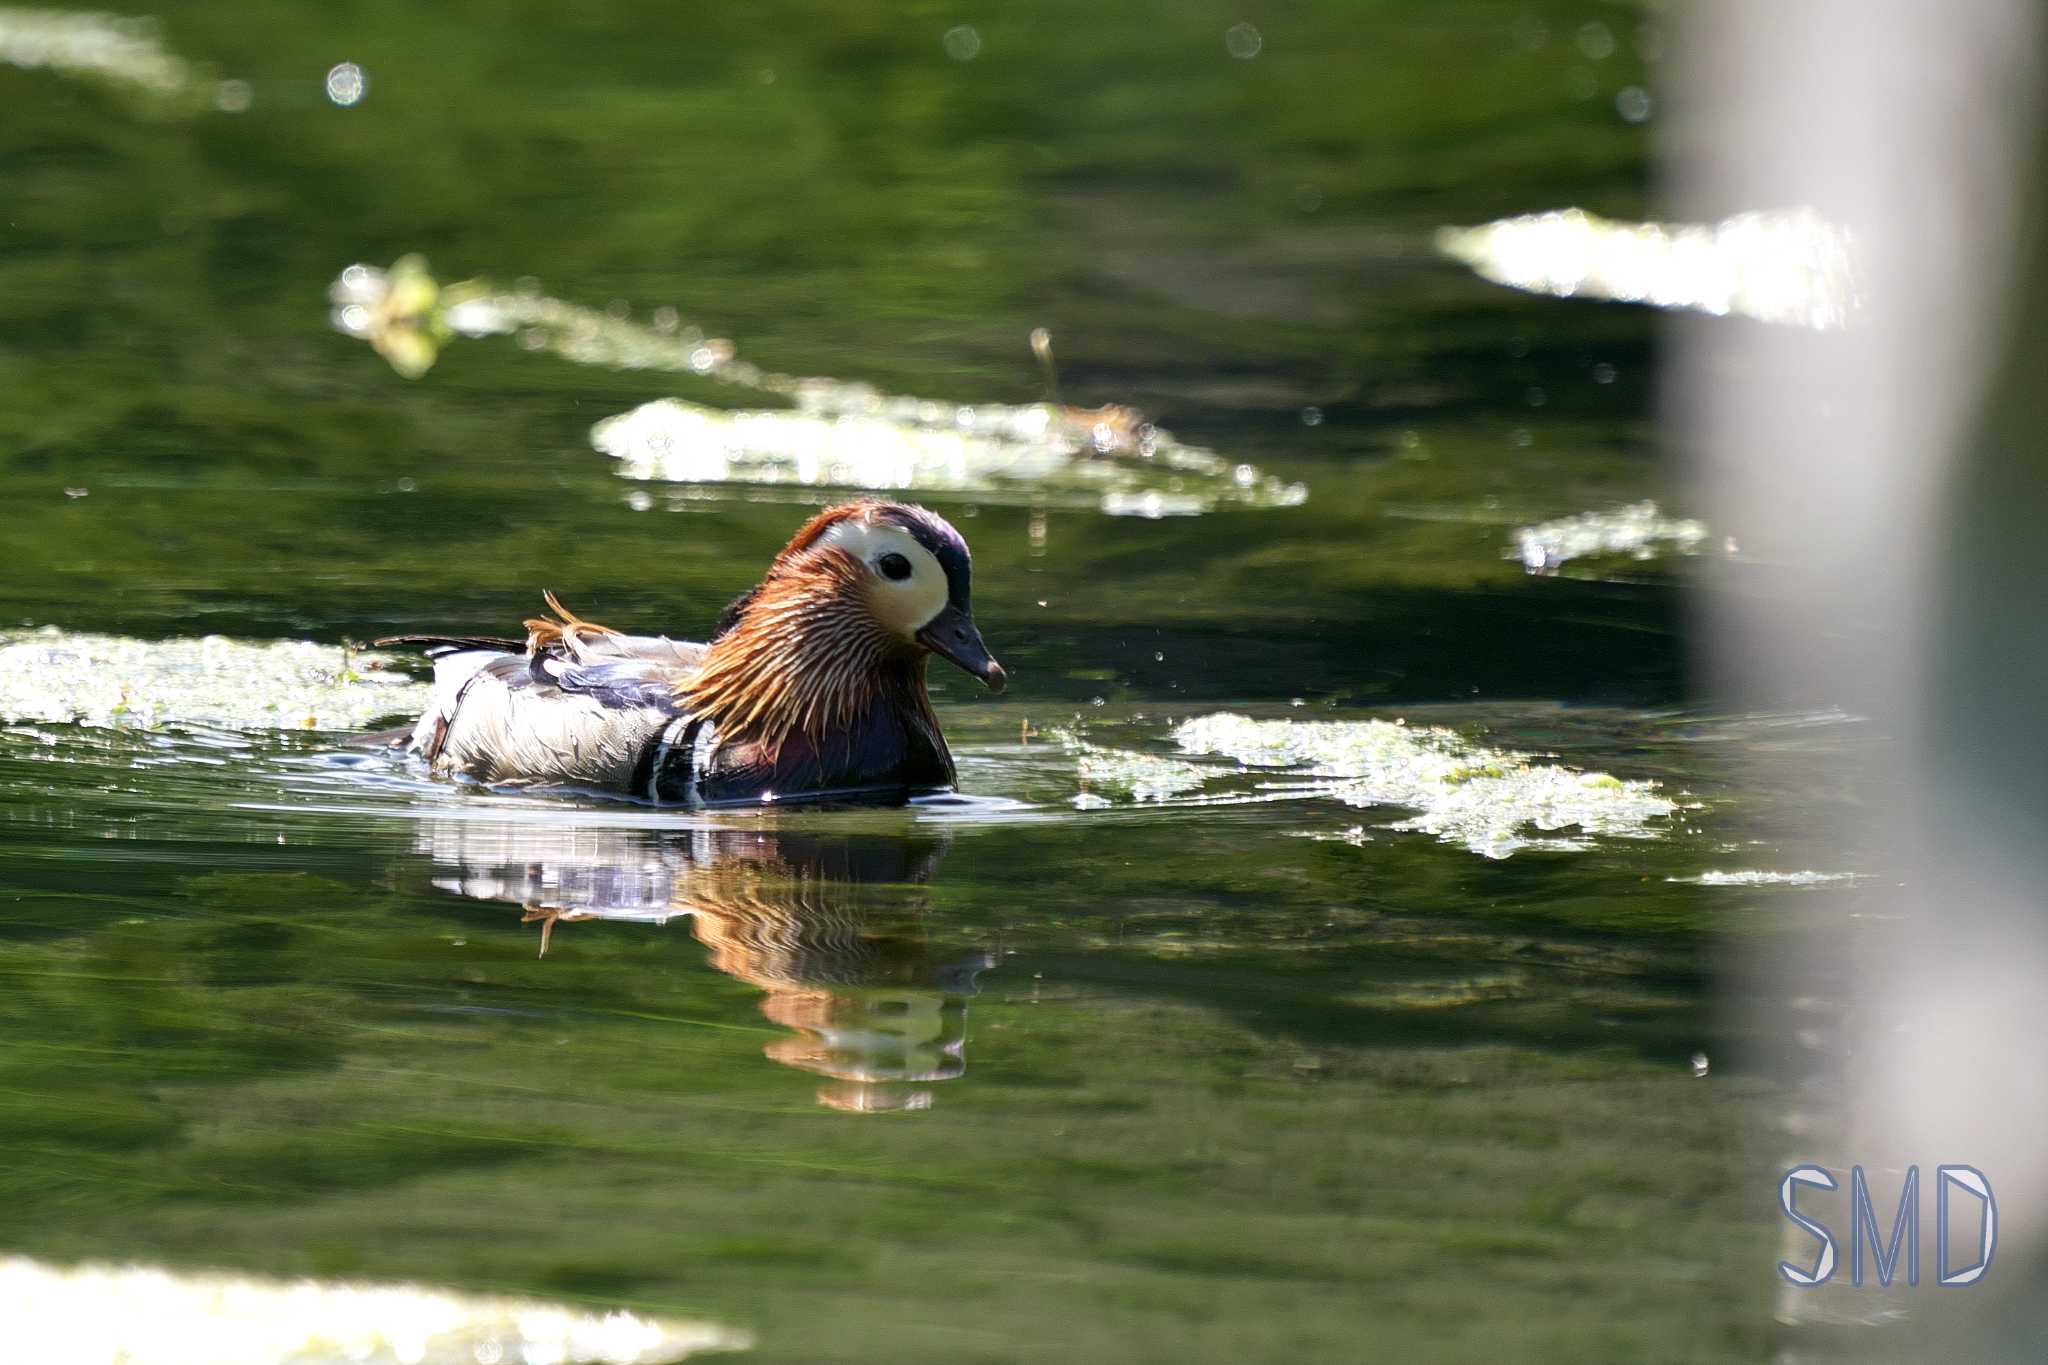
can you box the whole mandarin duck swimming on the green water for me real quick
[391,501,1004,804]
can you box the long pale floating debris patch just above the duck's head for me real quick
[328,256,1309,518]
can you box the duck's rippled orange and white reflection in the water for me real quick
[418,821,995,1113]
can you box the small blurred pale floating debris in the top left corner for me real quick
[0,8,250,113]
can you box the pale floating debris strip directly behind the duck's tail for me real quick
[0,626,426,731]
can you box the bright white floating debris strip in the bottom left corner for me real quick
[0,1257,754,1365]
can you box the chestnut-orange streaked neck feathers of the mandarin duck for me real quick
[678,553,938,769]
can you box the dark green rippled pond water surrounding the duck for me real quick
[0,0,1826,1361]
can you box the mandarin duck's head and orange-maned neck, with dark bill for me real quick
[686,499,1006,747]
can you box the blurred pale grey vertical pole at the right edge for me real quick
[1665,0,2048,1359]
